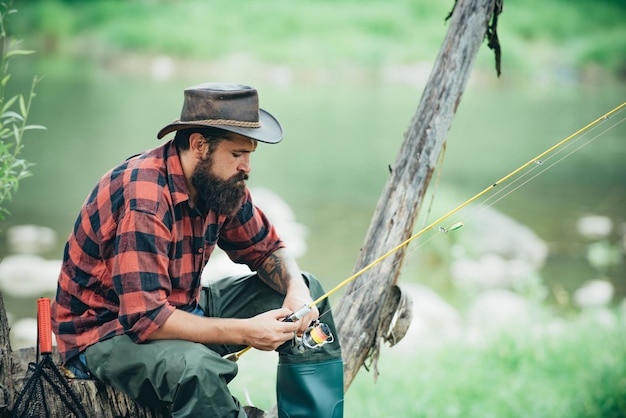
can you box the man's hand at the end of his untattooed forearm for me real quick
[245,308,300,351]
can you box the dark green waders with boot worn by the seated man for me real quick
[85,274,343,418]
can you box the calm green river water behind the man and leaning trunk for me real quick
[0,57,626,328]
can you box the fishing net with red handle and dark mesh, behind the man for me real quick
[12,298,87,418]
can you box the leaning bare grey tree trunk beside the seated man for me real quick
[335,0,494,390]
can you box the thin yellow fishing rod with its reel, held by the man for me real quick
[227,102,626,361]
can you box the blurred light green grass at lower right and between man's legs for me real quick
[231,314,626,418]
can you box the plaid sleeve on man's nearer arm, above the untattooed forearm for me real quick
[111,210,175,342]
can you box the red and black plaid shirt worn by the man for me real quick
[52,142,283,361]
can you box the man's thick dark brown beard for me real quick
[191,156,248,215]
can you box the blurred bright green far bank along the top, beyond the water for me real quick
[8,0,626,77]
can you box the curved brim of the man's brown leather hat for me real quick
[157,109,283,144]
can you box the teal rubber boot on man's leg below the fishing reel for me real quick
[276,358,343,418]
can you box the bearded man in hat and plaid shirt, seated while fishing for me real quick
[52,83,343,418]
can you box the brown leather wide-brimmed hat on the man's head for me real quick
[157,83,283,144]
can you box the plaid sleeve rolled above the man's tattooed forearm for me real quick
[218,190,285,271]
